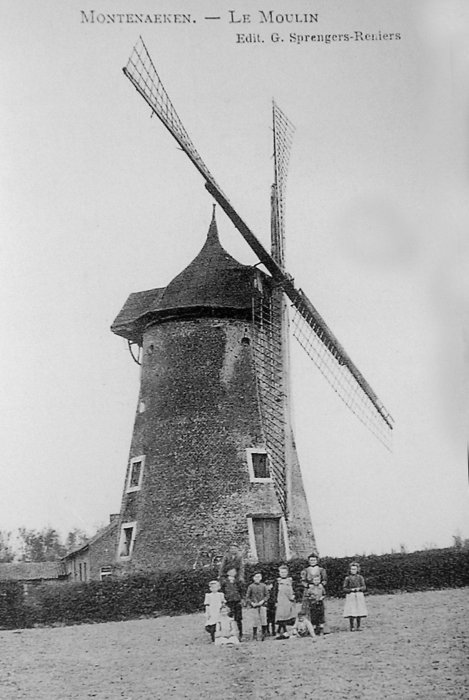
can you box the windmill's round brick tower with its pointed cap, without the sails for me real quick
[112,213,314,569]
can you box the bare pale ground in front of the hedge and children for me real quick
[0,588,469,700]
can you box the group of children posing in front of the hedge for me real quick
[204,554,367,645]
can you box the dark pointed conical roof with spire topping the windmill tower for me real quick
[158,212,253,312]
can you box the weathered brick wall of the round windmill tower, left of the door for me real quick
[120,318,281,570]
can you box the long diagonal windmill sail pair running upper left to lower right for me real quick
[123,37,393,446]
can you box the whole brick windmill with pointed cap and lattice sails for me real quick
[112,38,393,569]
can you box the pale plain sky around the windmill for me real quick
[0,0,469,556]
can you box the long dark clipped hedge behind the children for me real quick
[0,548,469,629]
